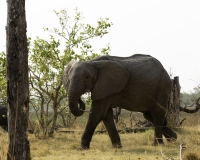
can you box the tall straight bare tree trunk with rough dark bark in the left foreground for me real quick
[6,0,30,160]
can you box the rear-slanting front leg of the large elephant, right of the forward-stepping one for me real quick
[103,108,122,148]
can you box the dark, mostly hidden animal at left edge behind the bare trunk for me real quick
[0,105,8,131]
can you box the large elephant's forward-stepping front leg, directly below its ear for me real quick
[79,97,112,150]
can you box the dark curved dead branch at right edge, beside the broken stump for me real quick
[180,97,200,113]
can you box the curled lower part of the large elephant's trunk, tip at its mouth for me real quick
[68,85,85,117]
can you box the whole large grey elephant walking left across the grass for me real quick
[63,54,177,149]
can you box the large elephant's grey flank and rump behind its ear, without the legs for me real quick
[114,55,171,111]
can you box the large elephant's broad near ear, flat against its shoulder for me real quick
[91,60,129,100]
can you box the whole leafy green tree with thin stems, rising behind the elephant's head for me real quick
[29,10,112,135]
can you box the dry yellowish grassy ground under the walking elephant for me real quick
[0,114,200,160]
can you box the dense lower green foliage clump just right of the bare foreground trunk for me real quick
[29,36,64,94]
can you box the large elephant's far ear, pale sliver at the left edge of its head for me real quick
[62,61,75,90]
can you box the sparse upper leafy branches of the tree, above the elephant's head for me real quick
[45,9,112,63]
